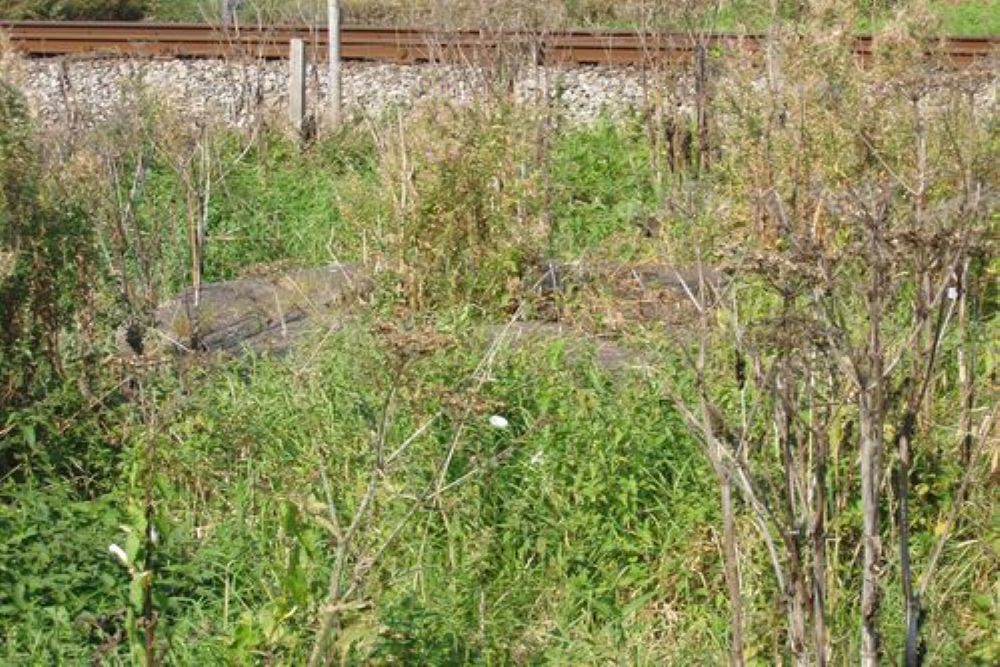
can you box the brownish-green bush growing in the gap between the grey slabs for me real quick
[380,103,548,312]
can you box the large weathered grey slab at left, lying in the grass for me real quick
[139,264,372,354]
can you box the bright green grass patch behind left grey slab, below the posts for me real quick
[148,133,375,289]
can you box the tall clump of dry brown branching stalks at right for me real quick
[670,5,996,665]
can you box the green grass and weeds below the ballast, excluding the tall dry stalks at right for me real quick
[0,5,1000,665]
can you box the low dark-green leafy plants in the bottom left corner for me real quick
[0,484,128,664]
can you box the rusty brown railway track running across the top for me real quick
[0,21,1000,65]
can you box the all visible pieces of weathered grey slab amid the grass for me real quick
[131,262,722,372]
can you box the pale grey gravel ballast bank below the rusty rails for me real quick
[18,58,664,126]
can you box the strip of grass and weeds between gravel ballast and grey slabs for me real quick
[68,107,648,298]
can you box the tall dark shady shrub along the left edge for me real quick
[0,82,96,486]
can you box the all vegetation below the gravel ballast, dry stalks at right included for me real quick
[0,3,1000,665]
